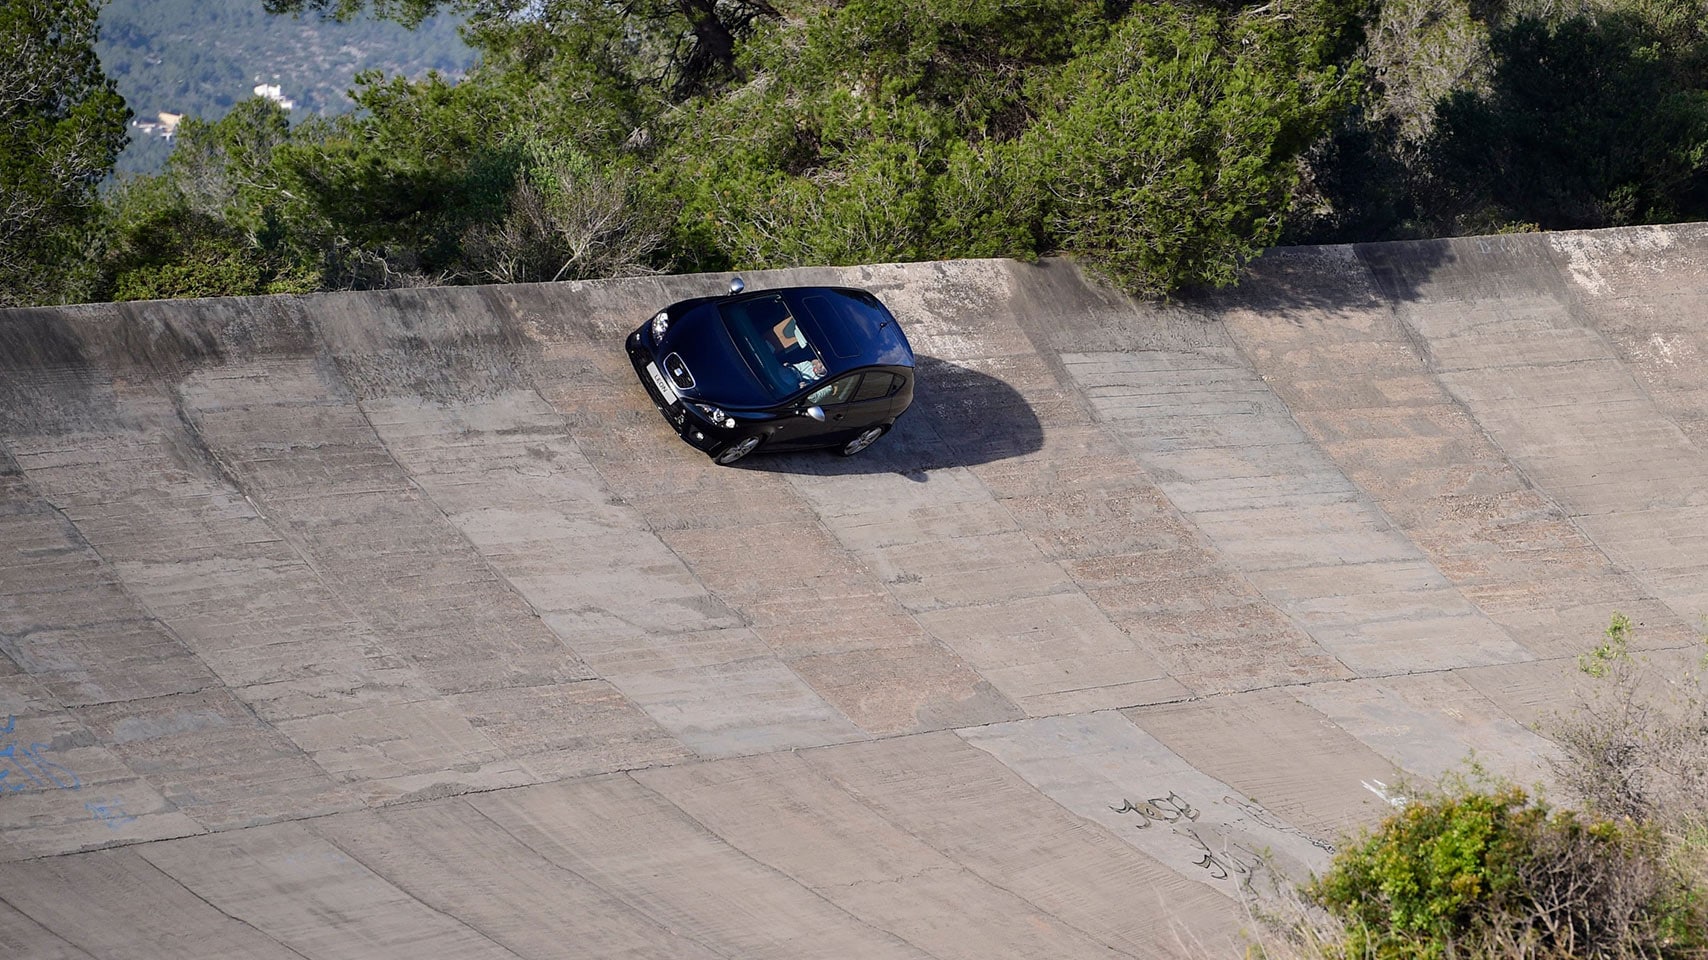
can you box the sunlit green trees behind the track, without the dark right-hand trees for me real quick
[10,0,1361,296]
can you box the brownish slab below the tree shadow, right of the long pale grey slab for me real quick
[1223,248,1689,656]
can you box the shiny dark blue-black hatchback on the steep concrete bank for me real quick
[627,278,914,465]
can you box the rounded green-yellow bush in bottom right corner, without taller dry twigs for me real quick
[1308,784,1708,960]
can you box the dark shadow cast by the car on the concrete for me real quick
[734,357,1044,483]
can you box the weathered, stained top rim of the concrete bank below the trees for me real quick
[0,224,1708,379]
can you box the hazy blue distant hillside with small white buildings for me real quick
[97,0,475,173]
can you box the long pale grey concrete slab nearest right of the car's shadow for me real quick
[1062,352,1530,675]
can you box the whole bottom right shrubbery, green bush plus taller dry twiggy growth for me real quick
[1252,613,1708,960]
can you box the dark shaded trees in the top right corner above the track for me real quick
[1286,0,1708,243]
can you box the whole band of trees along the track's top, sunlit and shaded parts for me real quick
[0,0,1708,299]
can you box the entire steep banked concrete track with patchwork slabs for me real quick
[0,225,1708,960]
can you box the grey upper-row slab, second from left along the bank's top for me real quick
[186,364,591,692]
